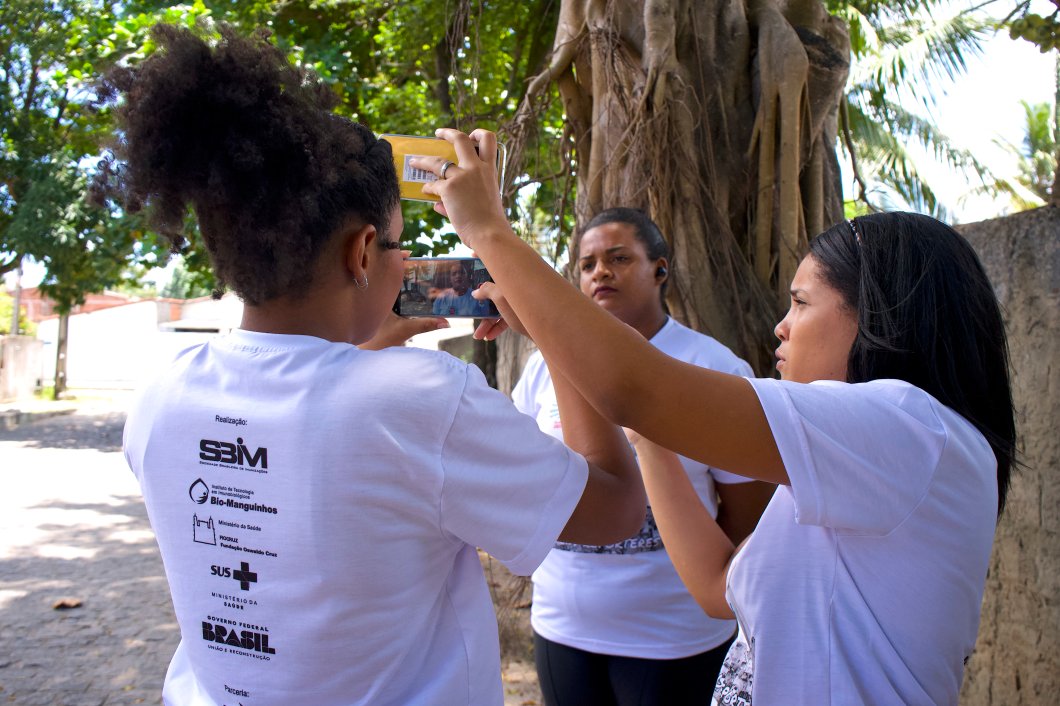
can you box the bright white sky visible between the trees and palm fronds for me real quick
[6,17,1057,287]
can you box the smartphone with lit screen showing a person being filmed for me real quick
[394,258,500,319]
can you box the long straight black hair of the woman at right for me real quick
[810,208,1015,510]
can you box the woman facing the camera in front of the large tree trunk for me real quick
[512,208,774,706]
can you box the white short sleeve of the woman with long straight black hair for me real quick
[750,378,947,534]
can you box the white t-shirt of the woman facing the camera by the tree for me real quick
[512,319,752,659]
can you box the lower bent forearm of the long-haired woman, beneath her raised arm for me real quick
[636,440,736,618]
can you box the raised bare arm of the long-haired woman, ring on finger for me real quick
[417,129,788,483]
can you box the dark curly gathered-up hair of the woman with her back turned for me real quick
[100,24,398,303]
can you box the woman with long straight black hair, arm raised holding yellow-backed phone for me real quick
[419,129,1015,705]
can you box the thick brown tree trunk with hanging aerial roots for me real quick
[507,0,849,374]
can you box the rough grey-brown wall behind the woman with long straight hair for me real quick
[960,207,1060,706]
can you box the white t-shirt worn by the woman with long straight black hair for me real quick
[713,380,997,706]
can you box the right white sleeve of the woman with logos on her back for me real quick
[441,366,588,576]
